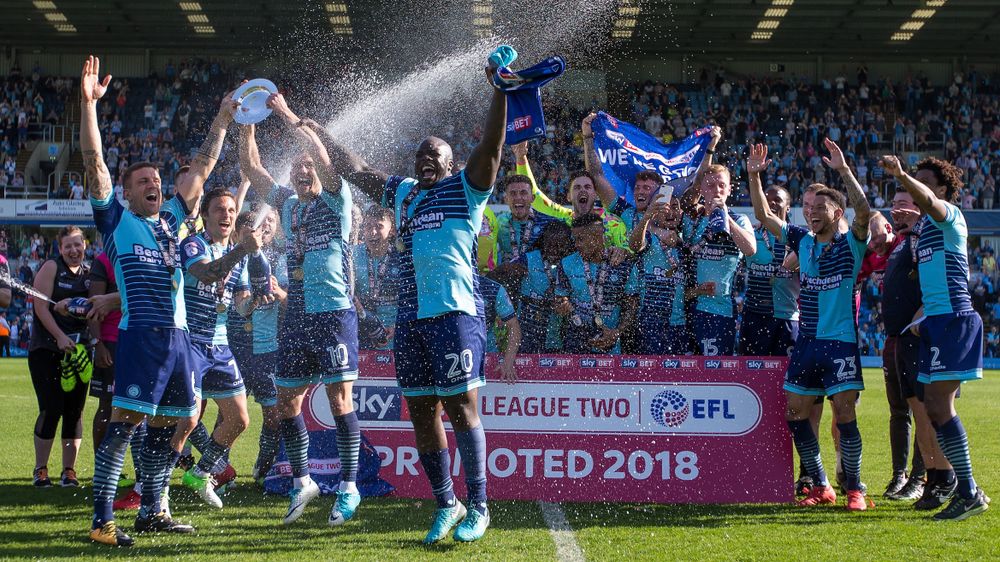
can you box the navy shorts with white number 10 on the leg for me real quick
[274,308,358,388]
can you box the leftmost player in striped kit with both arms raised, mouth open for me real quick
[80,57,235,546]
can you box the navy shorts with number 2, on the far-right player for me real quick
[917,310,983,384]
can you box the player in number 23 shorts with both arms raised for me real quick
[747,139,871,511]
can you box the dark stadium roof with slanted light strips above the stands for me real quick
[0,0,1000,57]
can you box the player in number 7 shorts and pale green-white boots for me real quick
[181,189,266,508]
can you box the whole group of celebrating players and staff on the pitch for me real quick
[0,52,995,546]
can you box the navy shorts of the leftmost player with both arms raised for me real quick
[111,328,201,418]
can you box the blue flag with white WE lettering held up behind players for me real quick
[591,111,712,203]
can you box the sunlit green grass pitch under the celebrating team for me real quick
[0,359,1000,562]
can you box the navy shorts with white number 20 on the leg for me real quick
[394,313,486,396]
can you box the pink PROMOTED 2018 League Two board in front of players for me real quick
[303,352,793,503]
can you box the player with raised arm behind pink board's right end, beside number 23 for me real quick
[740,182,799,356]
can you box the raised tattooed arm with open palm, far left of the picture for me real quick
[80,55,114,200]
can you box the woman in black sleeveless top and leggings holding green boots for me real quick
[28,226,90,487]
